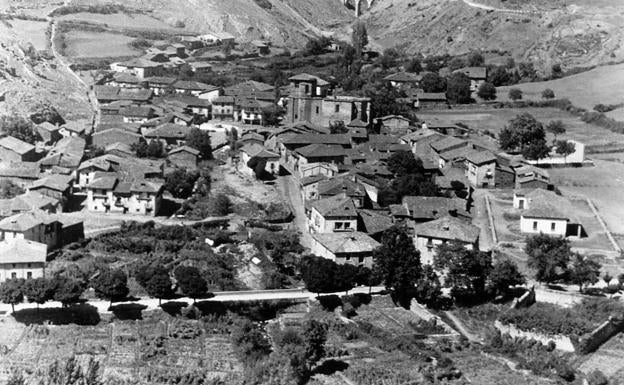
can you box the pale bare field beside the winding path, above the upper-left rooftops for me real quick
[65,30,140,59]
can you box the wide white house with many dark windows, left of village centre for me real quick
[86,173,164,216]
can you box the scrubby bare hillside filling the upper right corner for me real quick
[364,0,624,68]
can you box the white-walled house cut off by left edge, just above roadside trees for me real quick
[0,239,48,282]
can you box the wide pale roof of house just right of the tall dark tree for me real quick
[414,216,481,244]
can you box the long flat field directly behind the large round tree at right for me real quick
[418,108,624,153]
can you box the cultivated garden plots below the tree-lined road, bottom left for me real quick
[0,312,242,384]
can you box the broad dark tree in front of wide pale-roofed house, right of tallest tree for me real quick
[434,242,492,300]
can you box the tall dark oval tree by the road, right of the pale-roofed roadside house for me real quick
[373,225,422,307]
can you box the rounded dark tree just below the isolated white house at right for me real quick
[524,234,570,283]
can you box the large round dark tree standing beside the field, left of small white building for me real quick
[498,113,546,152]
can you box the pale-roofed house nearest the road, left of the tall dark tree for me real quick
[311,231,381,268]
